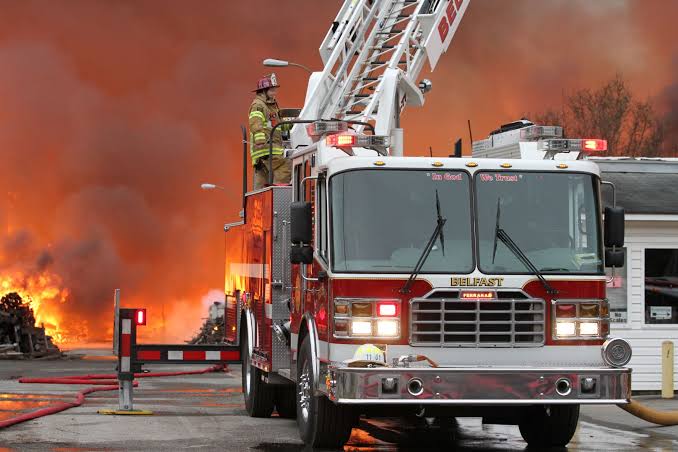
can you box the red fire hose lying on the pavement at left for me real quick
[0,365,224,429]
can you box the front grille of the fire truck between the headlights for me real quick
[410,291,545,347]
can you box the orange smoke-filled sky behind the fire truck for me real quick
[0,0,678,339]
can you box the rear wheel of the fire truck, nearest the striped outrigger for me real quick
[240,322,274,417]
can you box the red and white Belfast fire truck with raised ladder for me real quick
[224,0,631,447]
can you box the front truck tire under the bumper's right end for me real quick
[518,405,579,447]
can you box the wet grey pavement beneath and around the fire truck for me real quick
[0,350,678,452]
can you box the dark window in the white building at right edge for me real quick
[645,249,678,324]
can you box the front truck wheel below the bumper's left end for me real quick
[296,337,358,448]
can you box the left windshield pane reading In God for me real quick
[330,169,474,274]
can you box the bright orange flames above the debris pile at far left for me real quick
[0,271,88,344]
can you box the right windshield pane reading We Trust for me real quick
[475,171,603,274]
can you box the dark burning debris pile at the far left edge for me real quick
[0,292,61,359]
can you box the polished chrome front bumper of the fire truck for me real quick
[324,366,631,405]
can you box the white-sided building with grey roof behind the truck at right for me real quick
[595,159,678,391]
